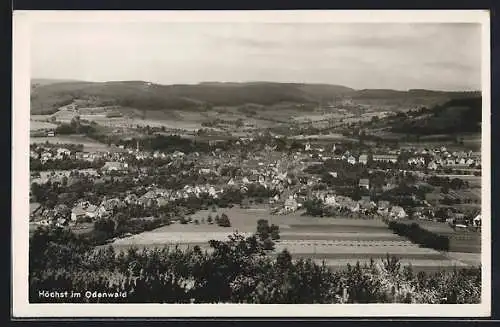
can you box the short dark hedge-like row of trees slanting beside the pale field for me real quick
[388,221,450,251]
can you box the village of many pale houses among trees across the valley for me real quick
[30,138,481,236]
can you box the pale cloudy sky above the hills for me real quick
[30,22,481,91]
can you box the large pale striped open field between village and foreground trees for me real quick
[106,206,480,271]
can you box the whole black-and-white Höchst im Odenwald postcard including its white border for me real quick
[12,11,491,317]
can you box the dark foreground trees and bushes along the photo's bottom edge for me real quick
[29,229,481,304]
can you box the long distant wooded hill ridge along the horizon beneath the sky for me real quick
[31,79,480,114]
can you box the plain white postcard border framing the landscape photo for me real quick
[11,10,491,318]
